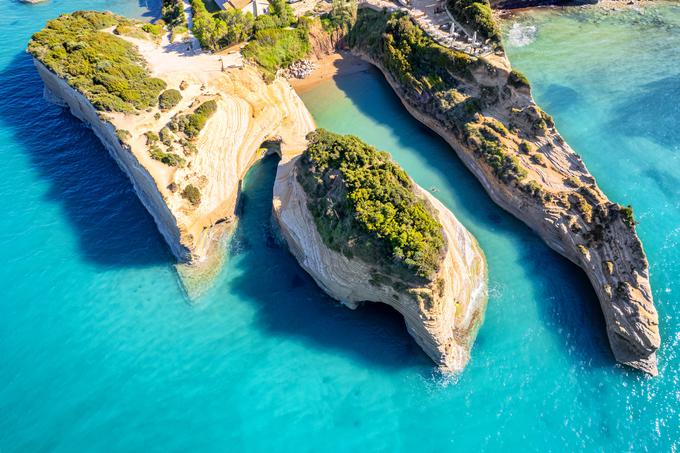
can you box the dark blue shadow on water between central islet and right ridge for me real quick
[335,61,614,367]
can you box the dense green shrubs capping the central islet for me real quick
[297,129,445,282]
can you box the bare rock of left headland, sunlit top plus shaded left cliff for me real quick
[29,11,314,282]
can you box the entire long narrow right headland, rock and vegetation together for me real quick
[349,10,661,375]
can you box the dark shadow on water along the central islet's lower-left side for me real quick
[226,156,432,373]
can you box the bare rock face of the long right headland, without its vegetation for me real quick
[342,17,660,376]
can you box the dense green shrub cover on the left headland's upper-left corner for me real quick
[28,11,166,113]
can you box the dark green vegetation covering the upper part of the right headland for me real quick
[348,10,540,183]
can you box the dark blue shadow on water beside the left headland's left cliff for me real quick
[0,53,173,266]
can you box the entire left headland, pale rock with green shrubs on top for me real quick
[29,12,314,263]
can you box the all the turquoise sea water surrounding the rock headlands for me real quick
[0,0,680,453]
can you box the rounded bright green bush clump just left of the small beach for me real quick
[242,28,310,82]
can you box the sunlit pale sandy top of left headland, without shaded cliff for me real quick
[106,31,315,261]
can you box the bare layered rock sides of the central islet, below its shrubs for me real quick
[274,159,487,372]
